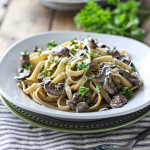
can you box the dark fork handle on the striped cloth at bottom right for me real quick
[128,128,150,148]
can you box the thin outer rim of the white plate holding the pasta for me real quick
[0,31,150,120]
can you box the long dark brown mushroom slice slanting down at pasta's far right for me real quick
[118,69,140,86]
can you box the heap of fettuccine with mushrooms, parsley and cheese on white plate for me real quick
[15,37,142,112]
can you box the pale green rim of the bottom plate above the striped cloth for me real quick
[0,95,150,134]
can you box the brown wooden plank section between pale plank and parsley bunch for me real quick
[51,11,77,31]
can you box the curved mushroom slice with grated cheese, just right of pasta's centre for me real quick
[93,64,110,83]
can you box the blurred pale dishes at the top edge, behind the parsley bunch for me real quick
[40,0,106,11]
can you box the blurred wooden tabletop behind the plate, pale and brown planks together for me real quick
[0,0,150,56]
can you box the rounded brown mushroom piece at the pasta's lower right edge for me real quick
[110,94,128,108]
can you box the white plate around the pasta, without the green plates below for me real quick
[0,31,150,120]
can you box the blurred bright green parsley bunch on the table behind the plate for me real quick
[74,0,145,40]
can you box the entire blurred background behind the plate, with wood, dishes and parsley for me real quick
[0,0,150,55]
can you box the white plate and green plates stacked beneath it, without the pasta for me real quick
[0,32,150,133]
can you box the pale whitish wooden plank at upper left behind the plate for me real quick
[0,0,52,55]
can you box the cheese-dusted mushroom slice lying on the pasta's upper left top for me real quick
[51,47,69,56]
